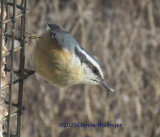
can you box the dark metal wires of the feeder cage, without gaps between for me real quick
[0,0,27,137]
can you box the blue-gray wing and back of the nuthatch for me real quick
[47,23,81,53]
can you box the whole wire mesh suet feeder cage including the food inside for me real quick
[0,0,33,137]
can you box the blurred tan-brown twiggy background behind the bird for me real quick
[13,0,160,137]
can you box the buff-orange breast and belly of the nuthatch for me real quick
[34,31,84,87]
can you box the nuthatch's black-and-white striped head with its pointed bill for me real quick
[74,46,116,92]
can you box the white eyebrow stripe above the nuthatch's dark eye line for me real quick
[78,47,104,78]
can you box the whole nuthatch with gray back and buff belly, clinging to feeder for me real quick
[34,24,115,92]
